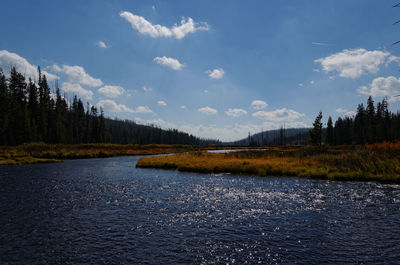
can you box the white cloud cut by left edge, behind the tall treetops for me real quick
[0,50,59,81]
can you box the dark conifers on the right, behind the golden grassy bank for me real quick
[310,96,400,145]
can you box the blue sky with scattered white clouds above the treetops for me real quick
[0,0,400,140]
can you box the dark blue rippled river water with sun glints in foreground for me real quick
[0,157,400,264]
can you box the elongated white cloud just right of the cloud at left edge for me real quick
[51,64,103,87]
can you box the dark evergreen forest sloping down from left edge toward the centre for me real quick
[0,67,219,145]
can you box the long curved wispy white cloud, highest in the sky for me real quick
[119,11,209,39]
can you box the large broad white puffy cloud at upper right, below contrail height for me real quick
[314,48,399,79]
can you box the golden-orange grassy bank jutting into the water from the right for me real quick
[137,142,400,182]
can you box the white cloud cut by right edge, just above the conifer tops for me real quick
[358,76,400,102]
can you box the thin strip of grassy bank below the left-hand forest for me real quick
[0,143,211,165]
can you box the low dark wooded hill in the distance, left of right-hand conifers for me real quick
[224,128,310,145]
